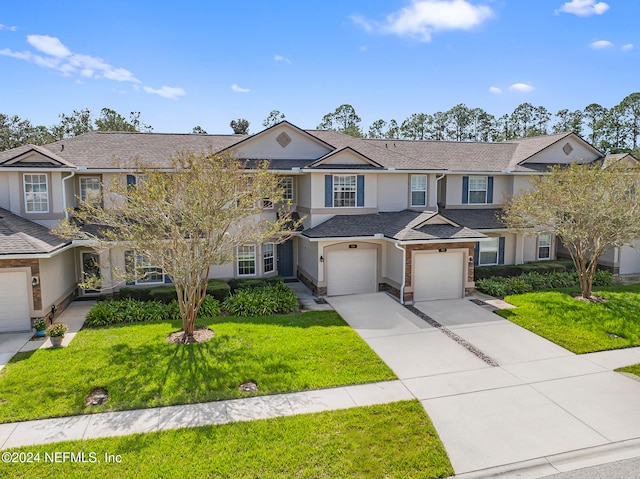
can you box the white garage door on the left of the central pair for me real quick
[326,248,378,296]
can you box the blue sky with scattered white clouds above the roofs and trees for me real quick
[0,0,640,133]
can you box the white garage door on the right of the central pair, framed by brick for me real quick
[413,253,464,301]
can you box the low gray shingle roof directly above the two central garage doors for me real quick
[302,210,485,241]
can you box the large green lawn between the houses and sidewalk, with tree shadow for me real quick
[0,311,395,422]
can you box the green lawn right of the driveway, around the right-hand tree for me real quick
[497,284,640,354]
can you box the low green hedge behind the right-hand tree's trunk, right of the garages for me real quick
[476,270,613,298]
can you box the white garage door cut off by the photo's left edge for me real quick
[0,271,31,333]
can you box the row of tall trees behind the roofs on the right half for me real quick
[317,93,640,153]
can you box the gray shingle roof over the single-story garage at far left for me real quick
[0,208,71,258]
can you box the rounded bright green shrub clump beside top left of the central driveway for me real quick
[223,283,299,316]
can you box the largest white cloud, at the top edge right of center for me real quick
[351,0,494,42]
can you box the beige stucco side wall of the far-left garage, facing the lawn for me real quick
[40,249,78,313]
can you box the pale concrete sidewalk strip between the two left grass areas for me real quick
[0,381,415,449]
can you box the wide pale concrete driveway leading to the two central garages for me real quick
[328,293,640,477]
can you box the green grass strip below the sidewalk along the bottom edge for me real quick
[0,401,453,479]
